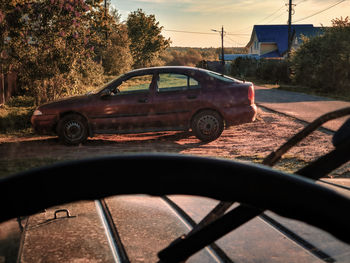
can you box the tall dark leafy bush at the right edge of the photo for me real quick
[292,17,350,94]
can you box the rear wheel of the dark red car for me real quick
[191,110,224,142]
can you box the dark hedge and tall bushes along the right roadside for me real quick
[231,17,350,94]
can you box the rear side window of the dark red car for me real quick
[157,73,199,92]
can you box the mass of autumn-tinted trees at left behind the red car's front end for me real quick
[0,0,170,103]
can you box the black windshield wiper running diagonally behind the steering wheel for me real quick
[158,107,350,262]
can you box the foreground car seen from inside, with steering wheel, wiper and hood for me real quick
[0,108,350,263]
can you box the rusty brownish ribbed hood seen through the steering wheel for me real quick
[15,180,350,263]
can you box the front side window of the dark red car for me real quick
[117,75,153,94]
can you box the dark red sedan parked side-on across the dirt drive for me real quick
[31,66,257,144]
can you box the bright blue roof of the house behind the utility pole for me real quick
[247,24,323,56]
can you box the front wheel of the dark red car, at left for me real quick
[57,114,88,145]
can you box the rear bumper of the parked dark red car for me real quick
[222,104,258,127]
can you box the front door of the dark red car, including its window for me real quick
[93,74,153,133]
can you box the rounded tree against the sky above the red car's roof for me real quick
[126,9,170,68]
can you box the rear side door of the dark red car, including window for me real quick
[153,72,201,128]
